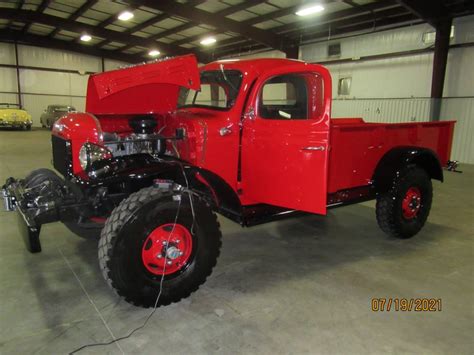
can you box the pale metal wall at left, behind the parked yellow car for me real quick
[0,43,125,126]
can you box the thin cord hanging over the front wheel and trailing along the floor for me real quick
[69,162,196,355]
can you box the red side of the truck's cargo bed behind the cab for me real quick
[328,118,455,193]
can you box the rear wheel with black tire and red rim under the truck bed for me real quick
[376,165,433,239]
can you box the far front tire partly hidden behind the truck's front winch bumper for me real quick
[25,168,102,239]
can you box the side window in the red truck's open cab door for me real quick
[258,73,313,120]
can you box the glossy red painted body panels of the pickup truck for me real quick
[53,56,455,214]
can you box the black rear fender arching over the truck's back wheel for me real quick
[372,147,443,192]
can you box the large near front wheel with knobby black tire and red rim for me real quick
[98,187,222,307]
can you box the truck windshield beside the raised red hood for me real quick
[178,70,242,110]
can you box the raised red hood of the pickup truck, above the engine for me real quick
[86,55,200,115]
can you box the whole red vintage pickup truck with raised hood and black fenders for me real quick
[3,55,454,307]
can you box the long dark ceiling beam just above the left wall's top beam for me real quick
[0,9,208,63]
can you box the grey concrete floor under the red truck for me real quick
[0,130,474,354]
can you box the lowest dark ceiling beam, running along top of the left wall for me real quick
[0,30,145,63]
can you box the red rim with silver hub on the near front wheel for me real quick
[142,223,193,276]
